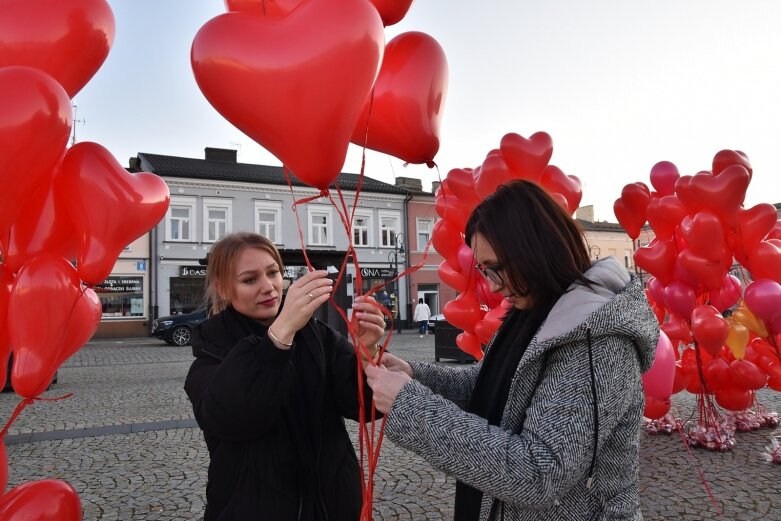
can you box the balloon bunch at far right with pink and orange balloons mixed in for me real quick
[614,150,781,450]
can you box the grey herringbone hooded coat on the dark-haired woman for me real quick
[385,257,659,521]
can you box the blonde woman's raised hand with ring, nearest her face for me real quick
[269,270,334,348]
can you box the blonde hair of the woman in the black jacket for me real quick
[206,232,284,316]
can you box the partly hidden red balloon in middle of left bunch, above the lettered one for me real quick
[0,174,80,272]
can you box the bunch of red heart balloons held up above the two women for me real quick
[191,0,448,191]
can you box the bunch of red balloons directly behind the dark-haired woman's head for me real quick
[431,132,583,360]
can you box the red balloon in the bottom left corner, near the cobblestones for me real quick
[0,479,82,521]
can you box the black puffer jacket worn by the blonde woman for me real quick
[184,308,372,521]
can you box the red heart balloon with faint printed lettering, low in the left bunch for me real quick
[8,254,101,398]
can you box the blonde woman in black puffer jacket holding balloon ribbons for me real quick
[185,233,385,521]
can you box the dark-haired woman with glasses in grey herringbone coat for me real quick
[366,181,659,521]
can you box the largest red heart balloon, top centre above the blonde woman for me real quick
[191,0,384,190]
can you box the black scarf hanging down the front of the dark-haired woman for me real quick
[453,308,549,521]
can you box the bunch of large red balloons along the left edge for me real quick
[0,0,169,520]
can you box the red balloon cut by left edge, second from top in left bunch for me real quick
[0,67,72,246]
